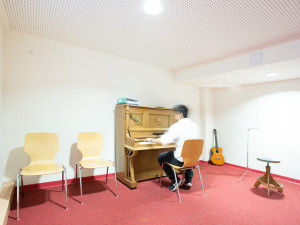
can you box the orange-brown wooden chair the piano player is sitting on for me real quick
[160,139,205,202]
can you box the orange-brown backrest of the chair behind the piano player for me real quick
[181,139,204,167]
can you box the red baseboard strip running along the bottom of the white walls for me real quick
[15,160,300,191]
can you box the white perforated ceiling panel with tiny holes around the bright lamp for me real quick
[3,0,300,71]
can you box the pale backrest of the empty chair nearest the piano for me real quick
[77,132,104,159]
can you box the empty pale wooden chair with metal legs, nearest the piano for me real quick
[76,132,118,204]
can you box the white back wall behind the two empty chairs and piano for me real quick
[3,32,200,184]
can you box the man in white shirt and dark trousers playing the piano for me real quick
[145,105,198,191]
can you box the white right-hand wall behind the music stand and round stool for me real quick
[214,79,300,180]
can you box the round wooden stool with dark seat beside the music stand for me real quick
[254,157,283,196]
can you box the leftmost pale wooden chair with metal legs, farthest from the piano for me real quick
[17,133,68,220]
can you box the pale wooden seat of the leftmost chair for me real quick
[21,163,64,176]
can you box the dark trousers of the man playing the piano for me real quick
[157,151,193,184]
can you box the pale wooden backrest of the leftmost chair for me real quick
[24,133,59,164]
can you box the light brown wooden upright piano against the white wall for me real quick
[115,104,175,188]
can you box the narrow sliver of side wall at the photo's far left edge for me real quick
[0,24,4,187]
